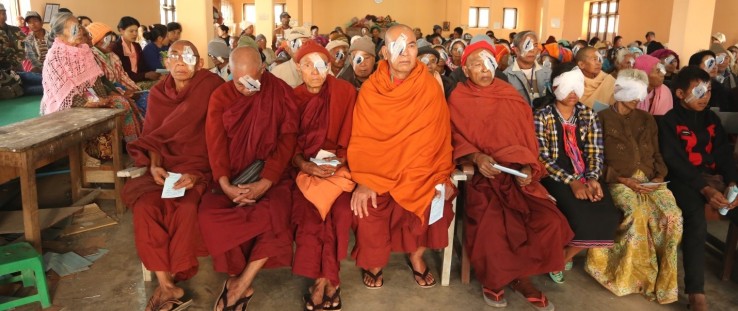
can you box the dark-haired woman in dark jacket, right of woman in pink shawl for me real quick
[113,16,161,90]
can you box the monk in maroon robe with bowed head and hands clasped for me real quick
[199,47,298,310]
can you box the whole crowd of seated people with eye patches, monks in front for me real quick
[12,7,738,310]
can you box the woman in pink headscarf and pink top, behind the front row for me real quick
[634,55,674,116]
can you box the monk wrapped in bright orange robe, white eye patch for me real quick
[348,25,455,288]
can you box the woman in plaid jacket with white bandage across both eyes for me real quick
[534,61,620,283]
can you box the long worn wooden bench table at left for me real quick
[0,108,125,252]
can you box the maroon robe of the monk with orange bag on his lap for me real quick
[292,75,356,286]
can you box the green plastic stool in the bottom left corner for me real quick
[0,242,51,310]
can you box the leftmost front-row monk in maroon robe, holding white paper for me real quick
[122,41,223,311]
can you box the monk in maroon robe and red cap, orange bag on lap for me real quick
[292,42,356,310]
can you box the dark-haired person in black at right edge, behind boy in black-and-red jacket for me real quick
[689,50,738,112]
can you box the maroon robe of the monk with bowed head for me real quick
[199,72,298,275]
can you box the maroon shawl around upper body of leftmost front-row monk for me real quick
[123,70,223,205]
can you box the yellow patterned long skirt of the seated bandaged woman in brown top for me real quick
[585,170,682,304]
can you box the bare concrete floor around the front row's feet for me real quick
[0,176,738,311]
